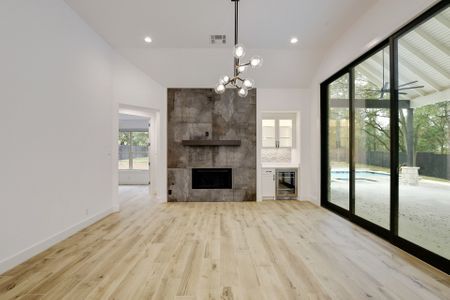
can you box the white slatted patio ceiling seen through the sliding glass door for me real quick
[357,8,450,107]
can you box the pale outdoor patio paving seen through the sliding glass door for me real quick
[331,176,450,258]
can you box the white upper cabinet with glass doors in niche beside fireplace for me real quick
[262,113,296,148]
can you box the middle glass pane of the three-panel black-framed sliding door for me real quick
[353,47,391,229]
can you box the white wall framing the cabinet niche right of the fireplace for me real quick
[256,89,312,201]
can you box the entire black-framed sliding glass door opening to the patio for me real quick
[321,1,450,272]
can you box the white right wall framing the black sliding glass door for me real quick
[309,0,439,203]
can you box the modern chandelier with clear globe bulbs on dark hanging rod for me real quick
[215,0,263,97]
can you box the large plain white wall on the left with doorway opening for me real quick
[0,0,165,274]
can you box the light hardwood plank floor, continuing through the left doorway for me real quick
[0,187,450,300]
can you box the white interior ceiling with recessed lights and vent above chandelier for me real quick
[66,0,377,88]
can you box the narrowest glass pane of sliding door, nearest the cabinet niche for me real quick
[328,74,350,210]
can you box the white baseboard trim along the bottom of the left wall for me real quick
[0,208,114,275]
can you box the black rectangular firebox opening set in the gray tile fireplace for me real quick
[192,168,233,189]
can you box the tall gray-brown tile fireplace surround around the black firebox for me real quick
[167,89,256,202]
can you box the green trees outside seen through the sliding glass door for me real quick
[329,69,450,165]
